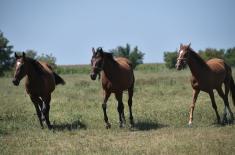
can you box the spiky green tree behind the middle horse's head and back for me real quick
[110,44,144,68]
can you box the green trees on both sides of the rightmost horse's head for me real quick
[164,47,235,69]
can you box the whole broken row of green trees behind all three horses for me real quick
[0,31,235,76]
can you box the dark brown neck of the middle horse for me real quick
[103,58,117,81]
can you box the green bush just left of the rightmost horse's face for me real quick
[164,51,177,69]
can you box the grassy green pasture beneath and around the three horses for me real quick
[0,65,235,155]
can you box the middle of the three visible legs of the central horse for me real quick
[115,92,125,128]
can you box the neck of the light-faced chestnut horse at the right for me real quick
[188,51,209,79]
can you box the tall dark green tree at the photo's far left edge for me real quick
[0,31,13,76]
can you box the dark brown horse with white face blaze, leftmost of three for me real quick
[12,52,65,129]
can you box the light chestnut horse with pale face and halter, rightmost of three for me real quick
[176,43,235,126]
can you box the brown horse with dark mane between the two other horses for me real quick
[90,48,135,128]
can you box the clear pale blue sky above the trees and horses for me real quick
[0,0,235,65]
